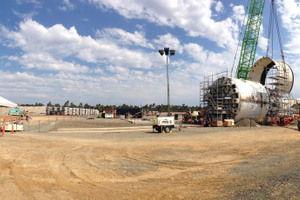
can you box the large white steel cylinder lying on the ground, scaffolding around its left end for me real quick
[204,77,270,122]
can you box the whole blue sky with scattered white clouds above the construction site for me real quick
[0,0,300,105]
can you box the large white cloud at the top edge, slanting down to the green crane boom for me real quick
[86,0,242,48]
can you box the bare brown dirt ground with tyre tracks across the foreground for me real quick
[0,117,300,199]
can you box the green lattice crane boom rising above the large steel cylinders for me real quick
[237,0,265,80]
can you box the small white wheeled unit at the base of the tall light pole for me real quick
[153,116,175,133]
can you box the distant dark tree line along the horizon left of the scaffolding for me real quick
[20,100,201,112]
